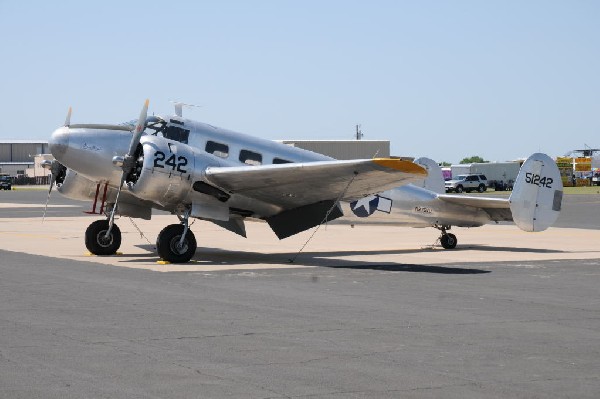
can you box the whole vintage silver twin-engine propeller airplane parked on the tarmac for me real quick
[45,100,562,263]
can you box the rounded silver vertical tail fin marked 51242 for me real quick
[510,153,563,231]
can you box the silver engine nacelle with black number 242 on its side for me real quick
[126,136,219,207]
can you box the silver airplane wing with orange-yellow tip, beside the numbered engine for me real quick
[206,158,427,209]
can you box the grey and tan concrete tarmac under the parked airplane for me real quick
[0,192,600,398]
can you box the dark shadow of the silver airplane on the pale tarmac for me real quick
[125,245,491,274]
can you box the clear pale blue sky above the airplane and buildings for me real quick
[0,0,600,162]
